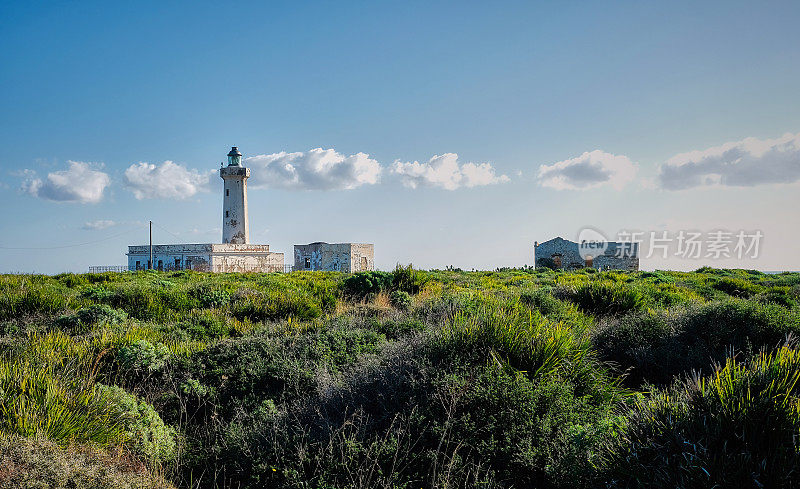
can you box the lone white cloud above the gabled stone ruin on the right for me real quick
[539,149,639,190]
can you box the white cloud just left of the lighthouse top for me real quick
[125,160,216,200]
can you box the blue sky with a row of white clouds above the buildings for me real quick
[0,1,800,273]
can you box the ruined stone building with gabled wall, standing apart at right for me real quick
[533,237,639,270]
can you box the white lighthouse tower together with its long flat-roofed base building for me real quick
[128,146,284,272]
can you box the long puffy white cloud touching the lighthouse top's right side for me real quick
[244,148,382,190]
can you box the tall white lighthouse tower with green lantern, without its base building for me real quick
[219,146,250,244]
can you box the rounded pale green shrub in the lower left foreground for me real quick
[97,384,176,463]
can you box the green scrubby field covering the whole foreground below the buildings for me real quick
[0,266,800,489]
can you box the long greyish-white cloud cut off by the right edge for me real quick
[658,133,800,190]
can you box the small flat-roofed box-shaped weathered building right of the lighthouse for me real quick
[294,242,375,272]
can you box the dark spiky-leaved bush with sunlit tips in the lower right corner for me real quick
[607,348,800,488]
